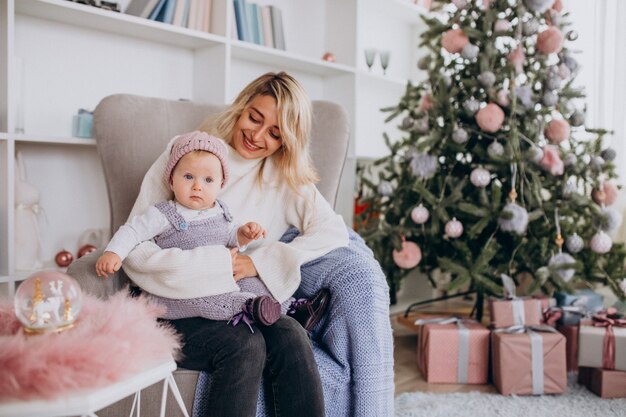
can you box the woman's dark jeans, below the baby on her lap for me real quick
[170,316,324,417]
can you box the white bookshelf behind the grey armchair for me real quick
[0,0,432,294]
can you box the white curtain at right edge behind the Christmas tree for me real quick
[563,0,626,242]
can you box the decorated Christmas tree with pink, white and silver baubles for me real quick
[357,0,626,310]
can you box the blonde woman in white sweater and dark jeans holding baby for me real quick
[124,72,348,417]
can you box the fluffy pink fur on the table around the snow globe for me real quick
[0,291,180,402]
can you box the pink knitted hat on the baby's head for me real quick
[165,130,229,188]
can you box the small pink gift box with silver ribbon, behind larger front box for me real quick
[489,298,542,329]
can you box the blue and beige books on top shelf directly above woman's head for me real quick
[232,0,286,50]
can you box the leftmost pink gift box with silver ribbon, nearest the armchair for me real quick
[417,319,490,384]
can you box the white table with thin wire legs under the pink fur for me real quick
[0,358,189,417]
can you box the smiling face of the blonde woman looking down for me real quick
[231,96,283,159]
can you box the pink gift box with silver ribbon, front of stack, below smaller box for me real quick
[491,326,567,395]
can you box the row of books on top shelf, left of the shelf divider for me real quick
[124,0,228,34]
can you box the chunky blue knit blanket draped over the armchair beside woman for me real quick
[193,229,394,417]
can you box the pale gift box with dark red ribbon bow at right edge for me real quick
[578,314,626,371]
